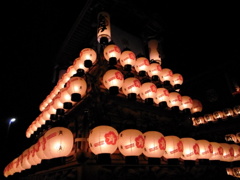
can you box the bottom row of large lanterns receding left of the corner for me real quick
[3,127,73,177]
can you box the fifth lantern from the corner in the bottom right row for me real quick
[181,137,199,160]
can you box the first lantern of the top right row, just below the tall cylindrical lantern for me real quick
[103,44,121,65]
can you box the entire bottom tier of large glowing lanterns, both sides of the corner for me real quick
[4,125,240,177]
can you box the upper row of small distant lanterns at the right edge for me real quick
[192,105,240,126]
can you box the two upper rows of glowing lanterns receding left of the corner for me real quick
[26,48,97,138]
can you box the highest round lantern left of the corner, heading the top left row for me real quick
[79,48,97,68]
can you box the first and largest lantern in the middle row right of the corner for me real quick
[103,69,124,94]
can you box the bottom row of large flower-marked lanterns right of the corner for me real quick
[88,125,240,162]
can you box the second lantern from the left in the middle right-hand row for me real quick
[122,77,141,99]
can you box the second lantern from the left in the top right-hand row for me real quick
[120,49,136,71]
